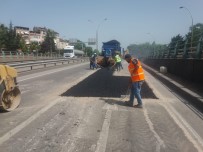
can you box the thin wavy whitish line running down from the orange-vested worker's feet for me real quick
[143,108,165,152]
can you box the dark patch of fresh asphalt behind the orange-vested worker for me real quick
[61,69,157,99]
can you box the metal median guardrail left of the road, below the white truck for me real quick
[7,58,89,72]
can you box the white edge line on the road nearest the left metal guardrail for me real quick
[18,64,88,82]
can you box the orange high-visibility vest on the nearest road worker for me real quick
[128,59,145,82]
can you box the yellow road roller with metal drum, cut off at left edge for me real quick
[0,64,21,111]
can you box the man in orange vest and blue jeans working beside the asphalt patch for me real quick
[125,54,145,108]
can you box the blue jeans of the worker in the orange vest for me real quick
[130,81,143,105]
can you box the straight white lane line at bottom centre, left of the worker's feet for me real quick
[95,104,112,152]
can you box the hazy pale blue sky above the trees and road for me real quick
[0,0,203,48]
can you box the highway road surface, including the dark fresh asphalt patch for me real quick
[0,63,203,152]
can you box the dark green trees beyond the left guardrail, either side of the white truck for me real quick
[0,23,96,56]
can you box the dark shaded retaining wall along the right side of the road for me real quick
[143,59,203,83]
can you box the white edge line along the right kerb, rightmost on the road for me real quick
[146,72,203,152]
